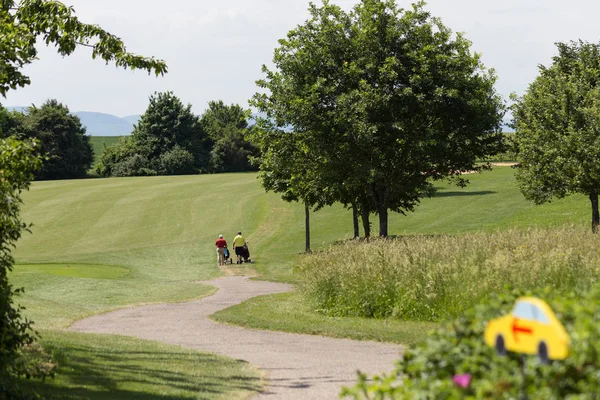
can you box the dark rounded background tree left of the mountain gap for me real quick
[21,100,94,179]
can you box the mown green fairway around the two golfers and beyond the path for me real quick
[11,167,589,398]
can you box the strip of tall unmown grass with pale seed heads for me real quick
[297,227,600,321]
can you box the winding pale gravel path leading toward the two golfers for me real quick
[70,276,402,400]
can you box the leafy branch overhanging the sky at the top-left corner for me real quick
[0,0,167,96]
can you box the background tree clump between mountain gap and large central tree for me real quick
[96,92,258,177]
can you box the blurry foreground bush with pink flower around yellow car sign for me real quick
[343,287,600,400]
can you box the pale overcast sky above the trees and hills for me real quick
[0,0,600,116]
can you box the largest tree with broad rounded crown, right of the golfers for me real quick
[253,0,504,236]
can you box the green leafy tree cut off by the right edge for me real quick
[513,41,600,232]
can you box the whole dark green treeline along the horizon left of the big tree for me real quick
[0,92,258,179]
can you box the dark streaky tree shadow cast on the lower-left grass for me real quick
[19,345,262,400]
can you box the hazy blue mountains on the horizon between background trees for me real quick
[6,107,141,136]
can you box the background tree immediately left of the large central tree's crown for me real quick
[200,101,258,172]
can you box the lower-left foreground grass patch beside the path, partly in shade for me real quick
[20,331,263,400]
